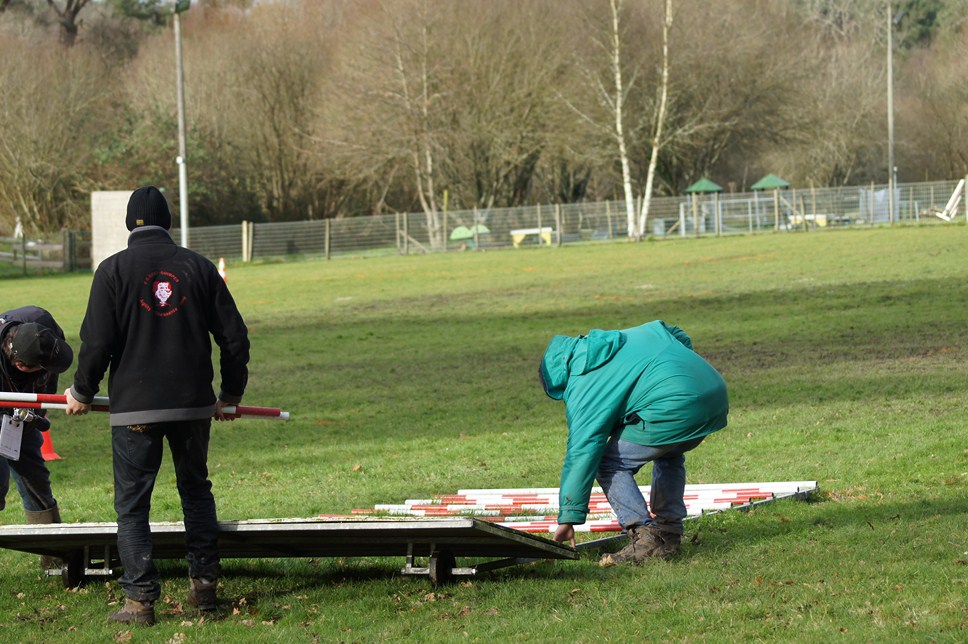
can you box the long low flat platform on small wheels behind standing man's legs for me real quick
[0,517,579,588]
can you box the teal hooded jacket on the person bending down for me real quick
[540,320,729,524]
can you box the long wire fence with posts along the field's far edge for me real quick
[0,181,968,273]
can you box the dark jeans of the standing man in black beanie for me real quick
[111,418,220,601]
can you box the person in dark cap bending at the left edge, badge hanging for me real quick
[0,306,74,569]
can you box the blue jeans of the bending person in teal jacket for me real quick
[598,438,703,535]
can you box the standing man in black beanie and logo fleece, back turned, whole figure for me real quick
[65,186,249,625]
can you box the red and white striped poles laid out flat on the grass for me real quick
[340,481,817,533]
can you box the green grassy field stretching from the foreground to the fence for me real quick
[0,226,968,642]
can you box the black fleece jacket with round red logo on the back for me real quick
[71,226,249,425]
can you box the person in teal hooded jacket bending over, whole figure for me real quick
[539,320,729,566]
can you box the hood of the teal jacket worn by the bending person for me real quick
[539,329,625,400]
